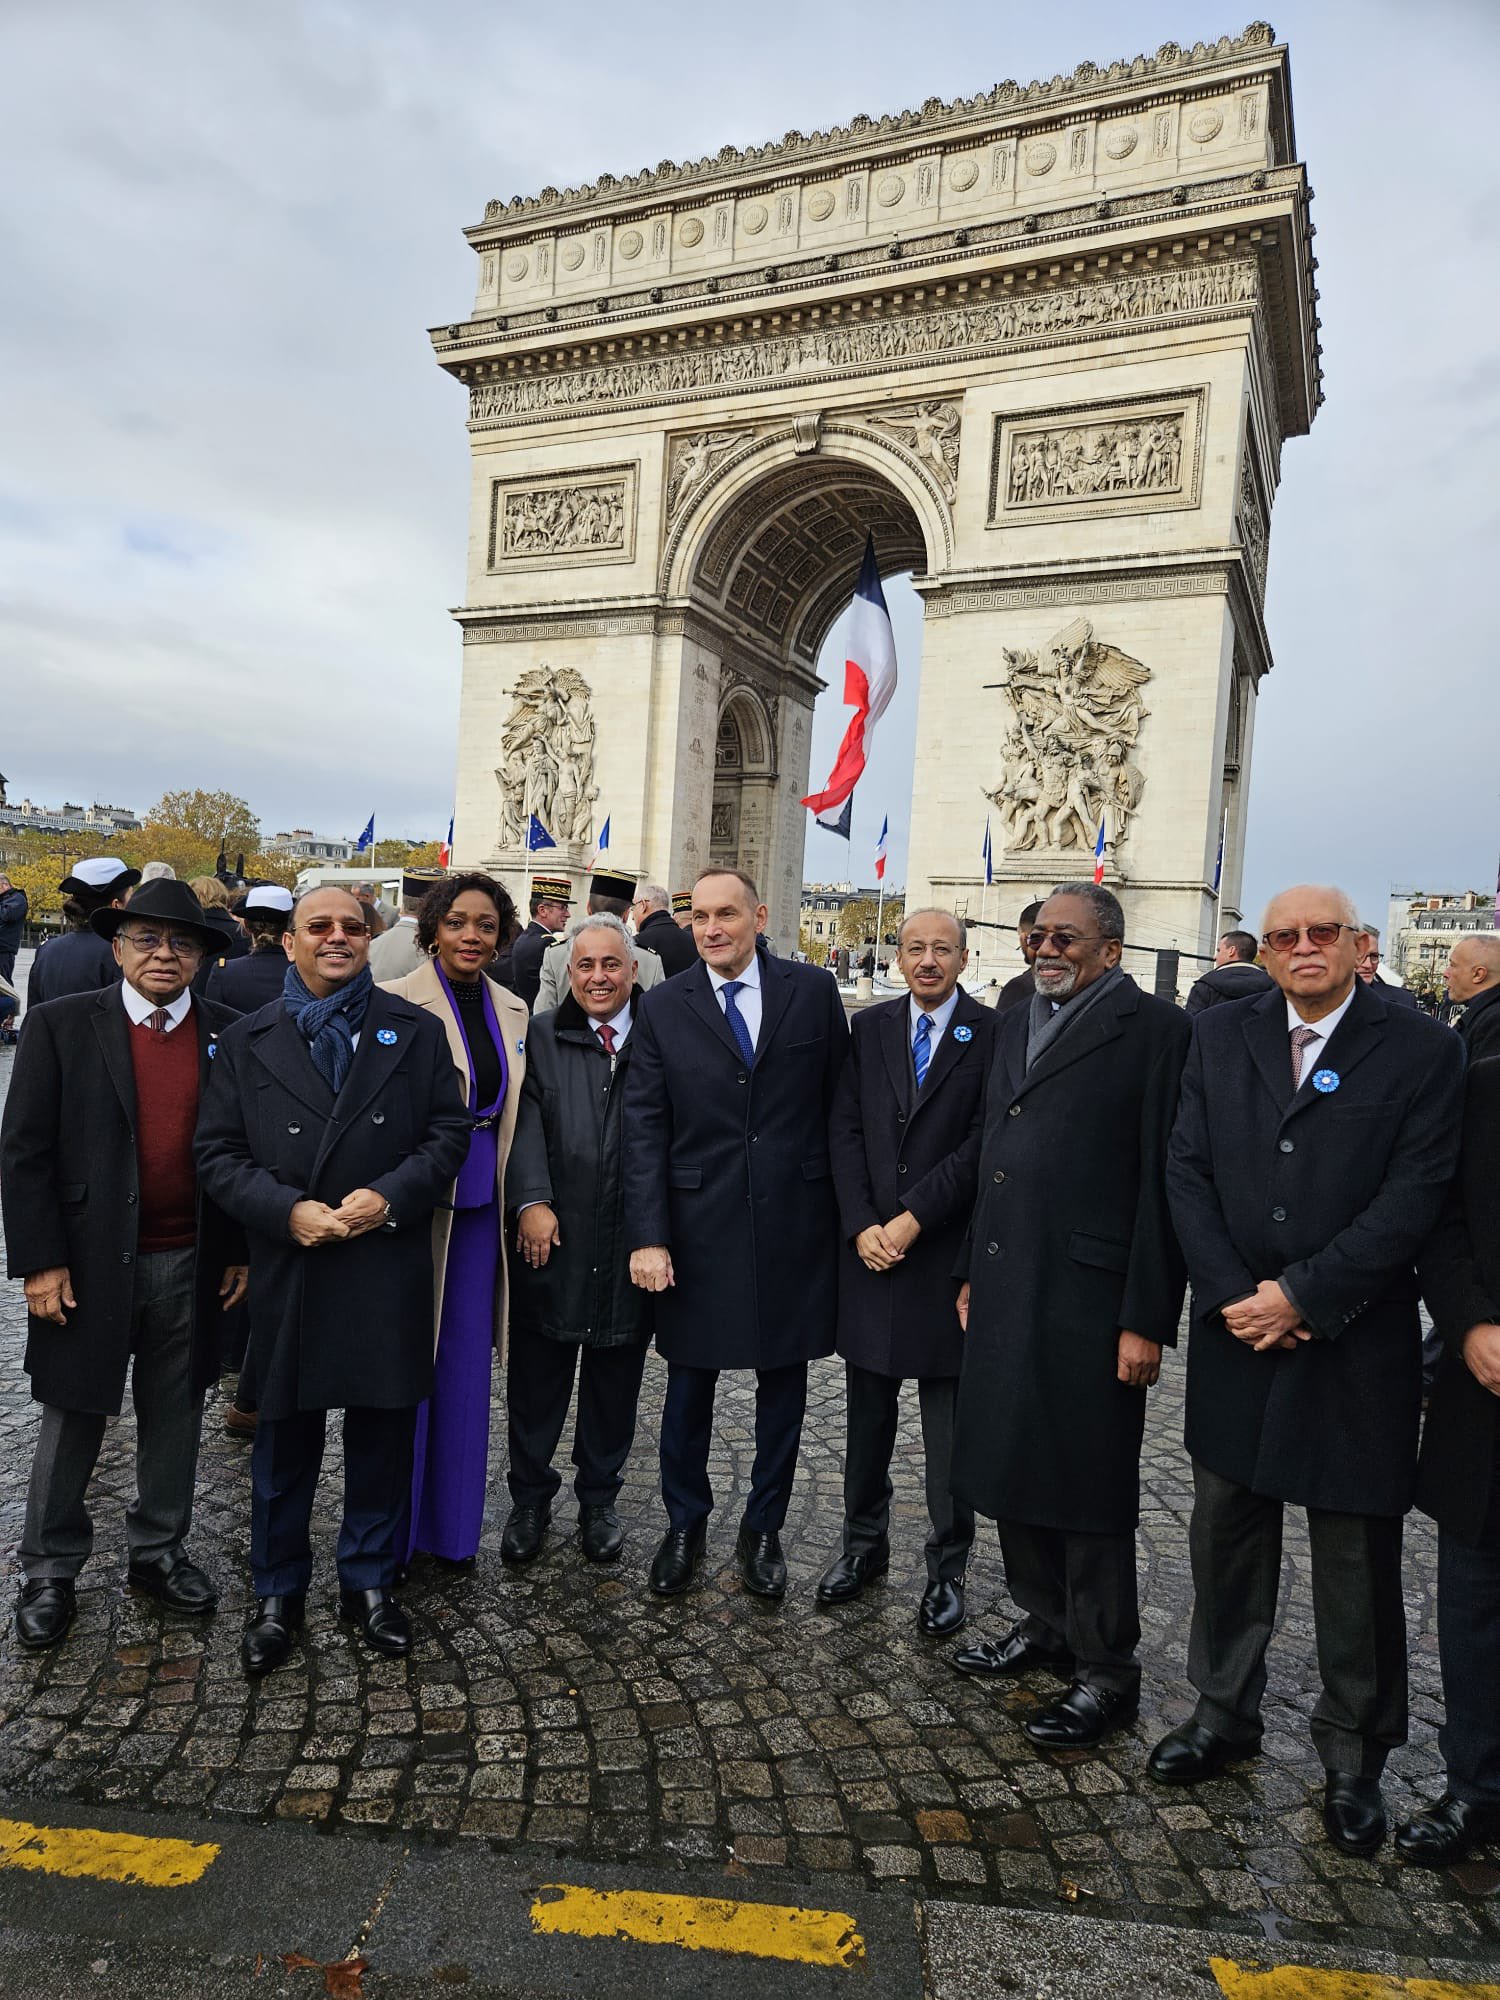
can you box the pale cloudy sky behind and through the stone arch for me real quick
[0,0,1500,936]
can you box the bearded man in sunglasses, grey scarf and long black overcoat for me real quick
[952,882,1192,1750]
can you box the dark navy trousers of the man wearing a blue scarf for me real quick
[250,1408,416,1598]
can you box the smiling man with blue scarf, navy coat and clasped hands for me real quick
[198,888,472,1676]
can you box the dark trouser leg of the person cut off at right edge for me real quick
[1438,1530,1500,1808]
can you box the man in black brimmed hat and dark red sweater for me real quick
[0,880,246,1652]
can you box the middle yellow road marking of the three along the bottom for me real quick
[532,1882,864,1966]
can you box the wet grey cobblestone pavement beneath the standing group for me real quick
[0,1052,1500,1958]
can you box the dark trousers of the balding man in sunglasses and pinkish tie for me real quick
[1188,1462,1406,1778]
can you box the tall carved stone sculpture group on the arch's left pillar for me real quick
[494,666,598,852]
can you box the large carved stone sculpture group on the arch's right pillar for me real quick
[984,618,1150,854]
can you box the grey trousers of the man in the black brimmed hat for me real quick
[20,1250,204,1582]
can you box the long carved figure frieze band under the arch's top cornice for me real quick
[470,256,1260,424]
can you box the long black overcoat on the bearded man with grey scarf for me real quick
[952,976,1192,1534]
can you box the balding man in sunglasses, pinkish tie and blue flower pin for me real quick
[1148,884,1464,1854]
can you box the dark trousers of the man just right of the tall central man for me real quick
[844,1362,974,1584]
